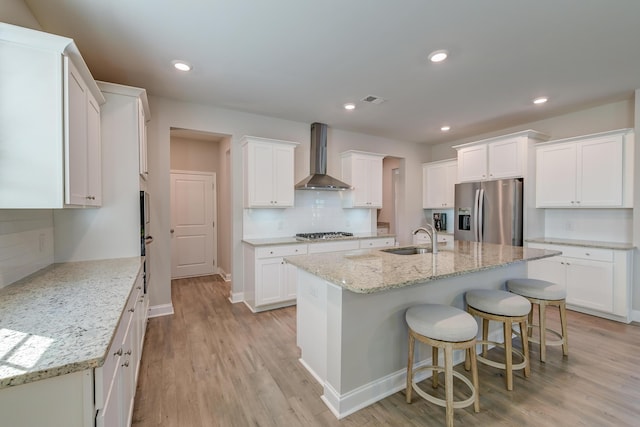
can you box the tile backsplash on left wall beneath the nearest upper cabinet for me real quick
[0,209,53,288]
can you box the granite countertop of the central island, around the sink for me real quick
[285,241,561,293]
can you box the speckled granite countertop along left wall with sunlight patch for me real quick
[0,257,142,389]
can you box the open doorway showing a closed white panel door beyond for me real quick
[170,128,231,281]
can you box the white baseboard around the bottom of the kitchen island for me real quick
[318,328,503,419]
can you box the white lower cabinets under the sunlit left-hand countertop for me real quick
[0,275,147,427]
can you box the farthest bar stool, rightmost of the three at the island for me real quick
[507,279,569,362]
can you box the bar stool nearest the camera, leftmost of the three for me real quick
[405,304,480,426]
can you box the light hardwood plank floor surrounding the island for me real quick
[133,276,640,427]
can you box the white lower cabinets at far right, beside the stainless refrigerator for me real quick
[528,243,632,323]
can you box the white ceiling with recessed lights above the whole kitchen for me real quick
[25,0,640,143]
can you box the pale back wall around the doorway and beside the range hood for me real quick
[142,96,429,305]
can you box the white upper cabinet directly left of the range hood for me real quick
[242,136,298,208]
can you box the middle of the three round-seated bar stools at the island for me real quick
[465,289,531,390]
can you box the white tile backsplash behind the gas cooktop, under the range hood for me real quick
[243,190,376,239]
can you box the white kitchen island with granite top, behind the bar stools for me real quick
[285,241,560,418]
